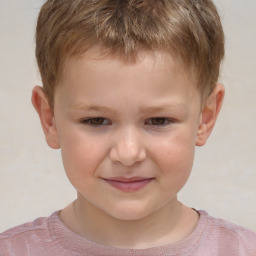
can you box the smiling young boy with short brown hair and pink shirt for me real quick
[0,0,256,256]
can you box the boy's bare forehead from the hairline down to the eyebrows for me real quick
[56,47,200,107]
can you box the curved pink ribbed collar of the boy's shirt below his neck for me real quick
[48,211,208,256]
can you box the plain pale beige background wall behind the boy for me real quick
[0,0,256,231]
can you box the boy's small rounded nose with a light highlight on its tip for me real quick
[110,128,146,166]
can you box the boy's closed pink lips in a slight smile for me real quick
[103,177,154,192]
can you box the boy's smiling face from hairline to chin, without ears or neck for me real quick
[54,51,201,220]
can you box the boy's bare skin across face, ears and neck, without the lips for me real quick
[32,49,224,248]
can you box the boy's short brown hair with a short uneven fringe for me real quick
[36,0,224,106]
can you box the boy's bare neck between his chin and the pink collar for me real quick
[60,196,198,249]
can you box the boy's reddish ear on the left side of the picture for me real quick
[31,86,60,149]
